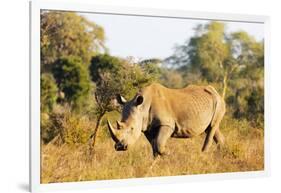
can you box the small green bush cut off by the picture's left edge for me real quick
[40,73,58,112]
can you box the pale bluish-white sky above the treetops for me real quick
[80,13,264,59]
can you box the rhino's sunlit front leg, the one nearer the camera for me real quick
[153,126,174,157]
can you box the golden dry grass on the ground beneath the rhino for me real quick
[41,115,264,183]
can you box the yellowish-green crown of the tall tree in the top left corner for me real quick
[40,11,106,72]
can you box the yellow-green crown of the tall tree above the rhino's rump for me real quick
[166,22,230,81]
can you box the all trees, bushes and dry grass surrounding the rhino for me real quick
[41,11,264,183]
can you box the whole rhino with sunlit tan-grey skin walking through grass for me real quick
[108,83,225,156]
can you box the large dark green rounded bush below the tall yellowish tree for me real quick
[52,57,91,110]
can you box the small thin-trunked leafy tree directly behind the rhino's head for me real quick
[90,54,153,151]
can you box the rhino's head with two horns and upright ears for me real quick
[107,94,145,151]
